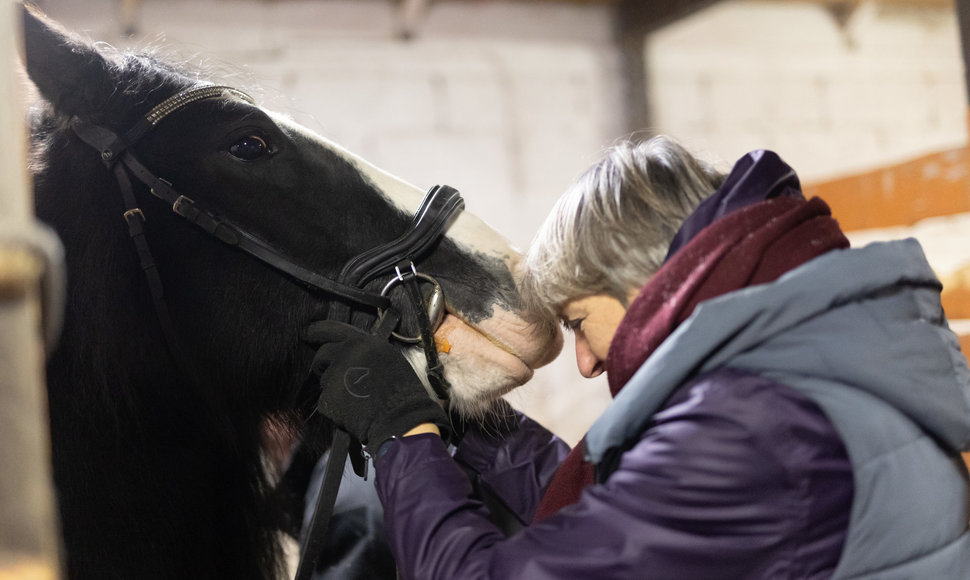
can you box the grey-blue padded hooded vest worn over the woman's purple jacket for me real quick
[586,240,970,580]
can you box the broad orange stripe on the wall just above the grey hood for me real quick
[804,147,970,231]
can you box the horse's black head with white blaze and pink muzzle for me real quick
[26,2,559,410]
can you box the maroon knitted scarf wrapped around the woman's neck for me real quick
[533,197,849,522]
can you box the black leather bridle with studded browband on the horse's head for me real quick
[71,85,464,580]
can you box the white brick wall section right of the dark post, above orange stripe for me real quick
[645,0,967,181]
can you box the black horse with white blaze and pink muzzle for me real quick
[23,6,562,580]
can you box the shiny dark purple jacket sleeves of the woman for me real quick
[376,369,853,580]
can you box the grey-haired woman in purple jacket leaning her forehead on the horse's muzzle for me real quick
[311,137,970,580]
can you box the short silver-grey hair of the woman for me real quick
[522,135,725,316]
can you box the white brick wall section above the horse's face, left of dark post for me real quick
[37,0,621,247]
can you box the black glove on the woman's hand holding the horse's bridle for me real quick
[307,320,449,457]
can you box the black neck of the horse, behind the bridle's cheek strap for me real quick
[37,139,288,578]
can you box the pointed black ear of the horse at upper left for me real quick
[23,4,116,115]
